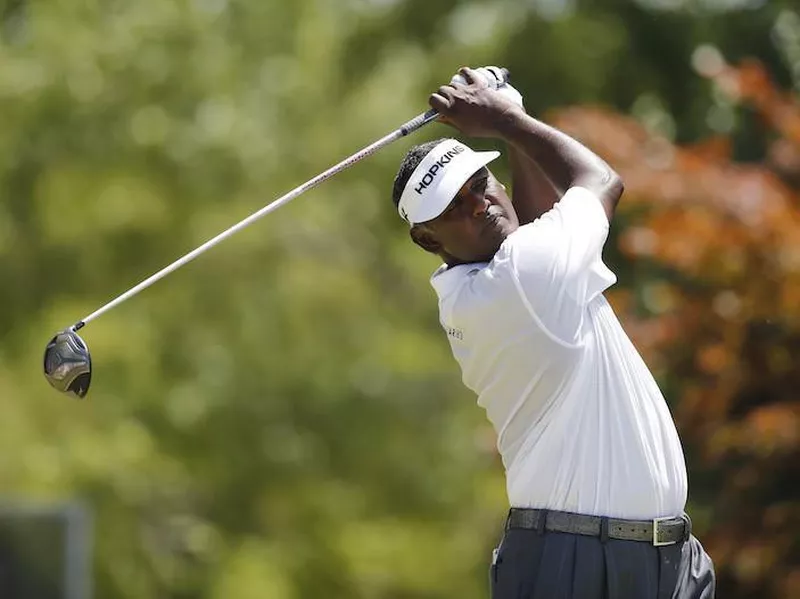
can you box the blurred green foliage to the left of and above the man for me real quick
[0,0,800,599]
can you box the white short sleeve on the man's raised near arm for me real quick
[507,187,616,343]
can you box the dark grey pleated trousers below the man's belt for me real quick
[490,529,715,599]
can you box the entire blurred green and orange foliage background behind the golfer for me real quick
[0,0,800,599]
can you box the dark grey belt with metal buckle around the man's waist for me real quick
[506,508,692,547]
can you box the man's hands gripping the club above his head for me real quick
[428,67,524,137]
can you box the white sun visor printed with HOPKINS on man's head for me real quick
[397,139,500,225]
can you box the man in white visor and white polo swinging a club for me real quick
[393,67,714,599]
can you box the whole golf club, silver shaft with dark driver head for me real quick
[44,67,509,399]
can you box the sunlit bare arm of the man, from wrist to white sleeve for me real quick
[497,109,623,219]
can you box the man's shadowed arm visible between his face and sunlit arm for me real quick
[508,144,566,225]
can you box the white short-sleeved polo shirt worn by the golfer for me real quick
[431,187,687,519]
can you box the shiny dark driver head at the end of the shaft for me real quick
[44,329,92,399]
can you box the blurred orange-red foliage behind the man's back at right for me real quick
[551,61,800,599]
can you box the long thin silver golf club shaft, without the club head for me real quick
[71,109,438,331]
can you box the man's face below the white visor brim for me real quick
[411,167,519,265]
